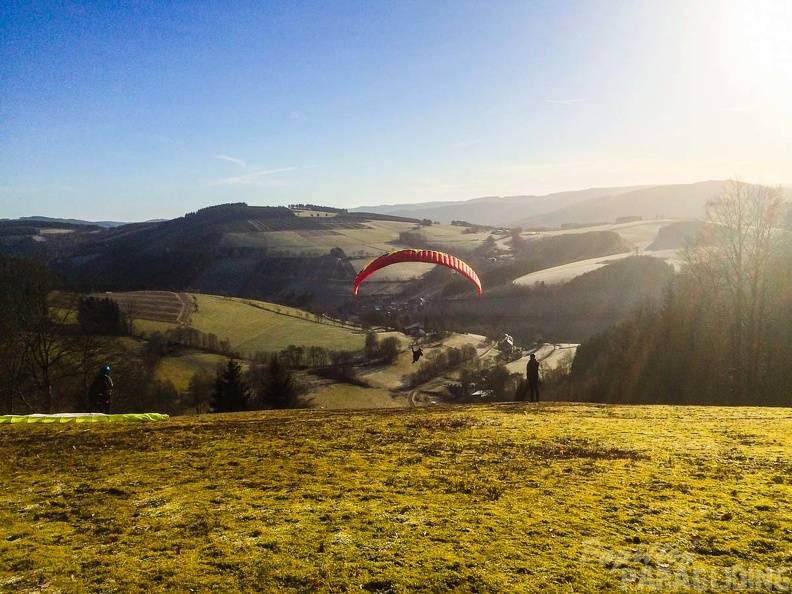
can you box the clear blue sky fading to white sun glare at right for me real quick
[0,0,792,221]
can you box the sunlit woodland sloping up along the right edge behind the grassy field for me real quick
[570,180,792,406]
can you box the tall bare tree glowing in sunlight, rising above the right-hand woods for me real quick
[684,180,784,403]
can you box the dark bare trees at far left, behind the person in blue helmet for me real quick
[0,256,181,414]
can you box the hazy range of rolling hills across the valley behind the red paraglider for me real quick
[0,182,736,342]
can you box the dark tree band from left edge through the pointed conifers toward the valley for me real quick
[0,256,414,414]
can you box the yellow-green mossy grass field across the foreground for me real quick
[0,403,792,593]
